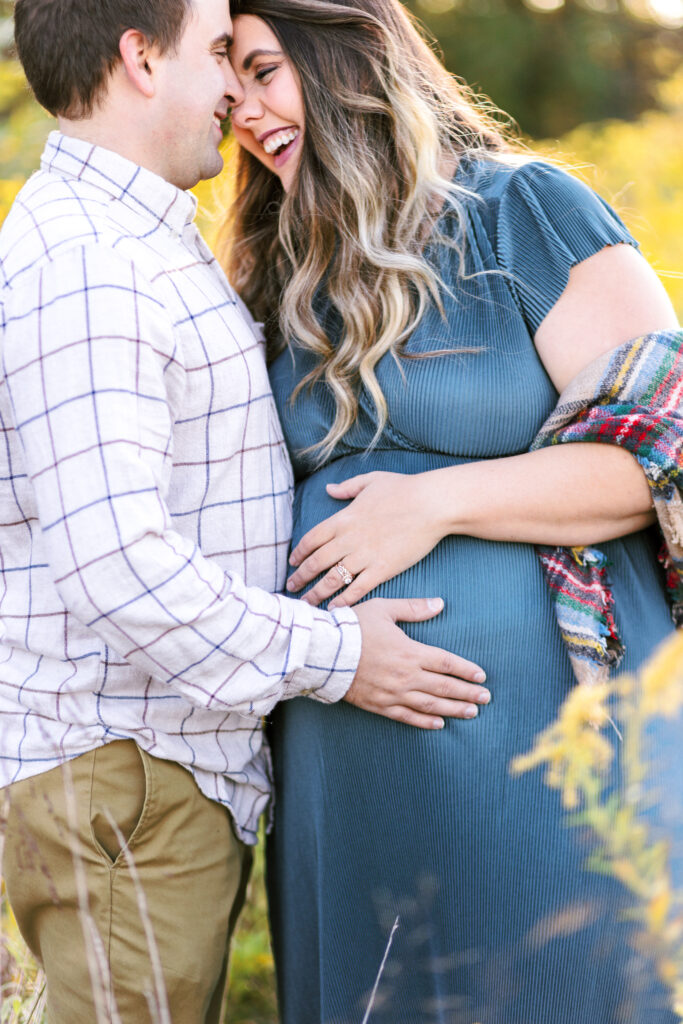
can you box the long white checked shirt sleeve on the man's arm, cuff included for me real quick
[3,245,360,716]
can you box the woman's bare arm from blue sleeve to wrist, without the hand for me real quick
[432,245,678,546]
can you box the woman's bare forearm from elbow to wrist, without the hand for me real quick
[428,442,655,546]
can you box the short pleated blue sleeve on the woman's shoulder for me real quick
[497,162,638,334]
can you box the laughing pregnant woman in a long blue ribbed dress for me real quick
[229,0,680,1024]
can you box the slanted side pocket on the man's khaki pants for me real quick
[90,739,147,865]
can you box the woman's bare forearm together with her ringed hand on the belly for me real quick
[287,442,654,607]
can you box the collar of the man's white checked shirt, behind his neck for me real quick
[41,131,197,234]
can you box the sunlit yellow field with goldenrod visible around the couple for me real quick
[0,0,683,1024]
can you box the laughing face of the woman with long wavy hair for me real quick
[230,14,304,191]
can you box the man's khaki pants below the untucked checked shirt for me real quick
[3,740,251,1024]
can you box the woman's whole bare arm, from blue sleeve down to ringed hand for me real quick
[288,245,678,605]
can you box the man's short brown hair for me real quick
[14,0,191,118]
